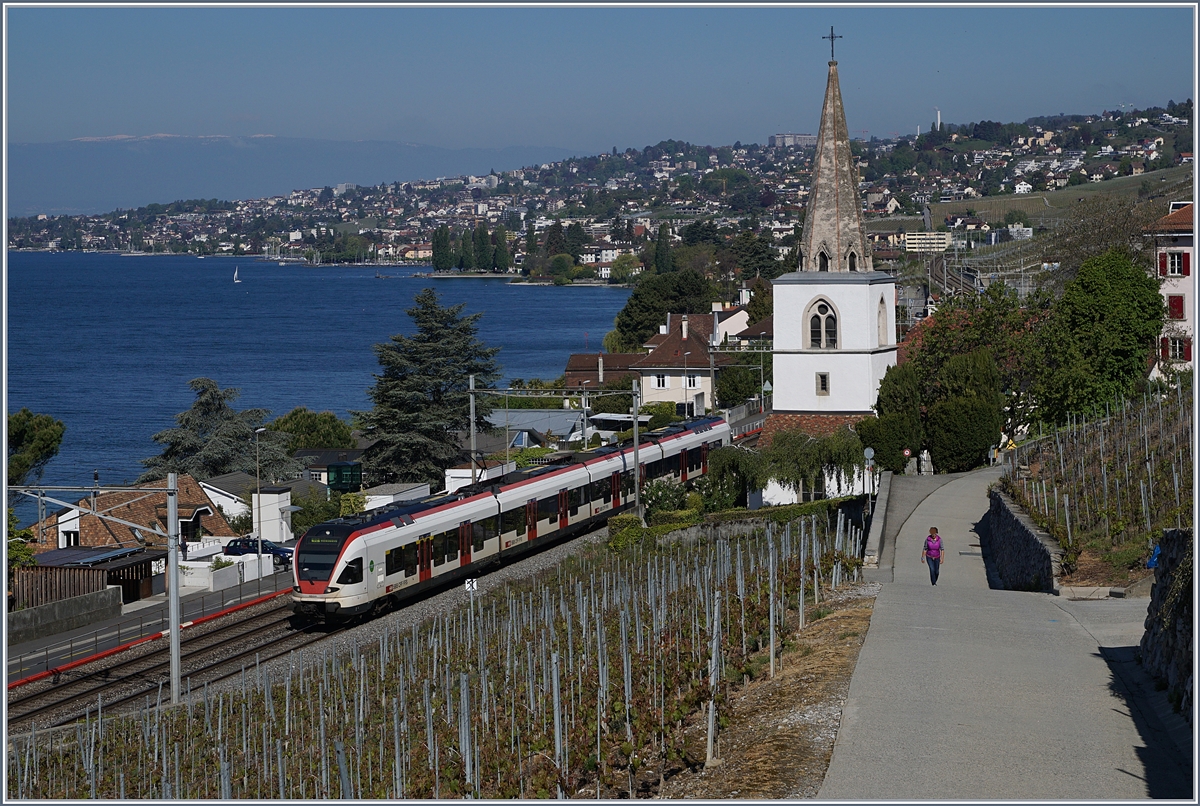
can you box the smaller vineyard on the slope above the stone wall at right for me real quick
[1001,384,1193,573]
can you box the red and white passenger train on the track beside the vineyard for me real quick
[292,417,730,619]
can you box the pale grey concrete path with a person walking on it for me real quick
[818,469,1193,800]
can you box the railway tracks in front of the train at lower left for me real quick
[7,605,346,733]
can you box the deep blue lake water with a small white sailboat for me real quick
[7,253,629,503]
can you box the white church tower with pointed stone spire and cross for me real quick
[764,39,896,440]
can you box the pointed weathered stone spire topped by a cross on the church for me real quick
[798,54,872,271]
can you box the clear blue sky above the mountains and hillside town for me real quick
[5,6,1194,154]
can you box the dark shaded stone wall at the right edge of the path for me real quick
[1141,529,1193,723]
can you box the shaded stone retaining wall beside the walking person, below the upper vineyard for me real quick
[982,489,1062,593]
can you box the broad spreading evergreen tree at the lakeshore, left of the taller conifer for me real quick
[138,378,302,483]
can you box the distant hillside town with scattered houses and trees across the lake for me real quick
[7,100,1193,283]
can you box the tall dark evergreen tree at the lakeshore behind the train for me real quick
[354,288,499,487]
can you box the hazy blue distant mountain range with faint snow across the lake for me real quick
[7,134,575,216]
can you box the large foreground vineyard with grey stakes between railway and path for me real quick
[7,501,860,800]
